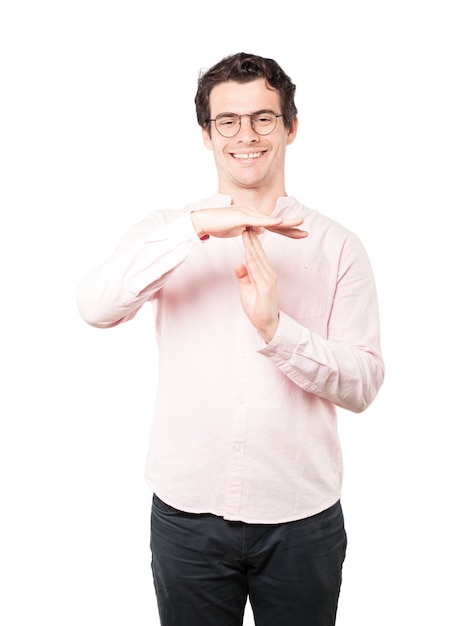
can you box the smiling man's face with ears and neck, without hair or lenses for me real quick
[203,78,297,195]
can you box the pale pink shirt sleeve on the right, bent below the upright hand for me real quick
[259,233,384,413]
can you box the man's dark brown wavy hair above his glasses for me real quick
[195,52,297,129]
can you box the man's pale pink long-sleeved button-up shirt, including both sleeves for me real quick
[78,194,384,523]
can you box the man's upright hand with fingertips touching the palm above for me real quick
[234,230,279,343]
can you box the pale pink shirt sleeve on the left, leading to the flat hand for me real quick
[77,211,204,328]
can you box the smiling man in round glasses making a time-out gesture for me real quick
[78,53,383,626]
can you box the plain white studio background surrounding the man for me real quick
[0,0,472,626]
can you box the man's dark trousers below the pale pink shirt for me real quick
[151,496,346,626]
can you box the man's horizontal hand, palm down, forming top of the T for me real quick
[190,206,308,239]
